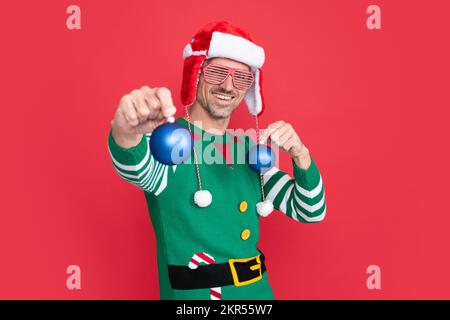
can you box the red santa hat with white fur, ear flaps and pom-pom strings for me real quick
[181,21,273,216]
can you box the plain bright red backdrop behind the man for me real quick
[0,0,450,299]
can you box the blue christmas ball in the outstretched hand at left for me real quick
[150,118,194,165]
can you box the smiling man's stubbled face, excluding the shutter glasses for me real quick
[197,58,250,119]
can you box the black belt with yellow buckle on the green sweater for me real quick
[168,253,266,290]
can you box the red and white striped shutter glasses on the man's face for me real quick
[201,64,255,90]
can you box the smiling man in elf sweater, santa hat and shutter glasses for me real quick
[108,22,326,299]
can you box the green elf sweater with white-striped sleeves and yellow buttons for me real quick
[108,118,326,299]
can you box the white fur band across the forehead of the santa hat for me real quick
[208,31,265,68]
